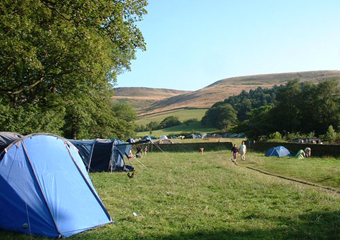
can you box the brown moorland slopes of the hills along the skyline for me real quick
[113,71,340,116]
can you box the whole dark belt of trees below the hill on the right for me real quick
[202,79,340,139]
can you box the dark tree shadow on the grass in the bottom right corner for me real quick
[143,211,340,240]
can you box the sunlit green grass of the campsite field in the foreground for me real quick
[0,151,340,240]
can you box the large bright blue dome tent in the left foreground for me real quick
[0,134,112,238]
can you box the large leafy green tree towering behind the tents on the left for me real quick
[0,0,147,137]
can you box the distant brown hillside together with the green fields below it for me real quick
[117,71,340,136]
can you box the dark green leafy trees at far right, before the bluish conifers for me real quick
[236,79,340,139]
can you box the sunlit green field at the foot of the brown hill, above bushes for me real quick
[136,108,208,125]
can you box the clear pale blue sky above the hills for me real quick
[116,0,340,91]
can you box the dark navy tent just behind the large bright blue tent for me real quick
[69,139,134,172]
